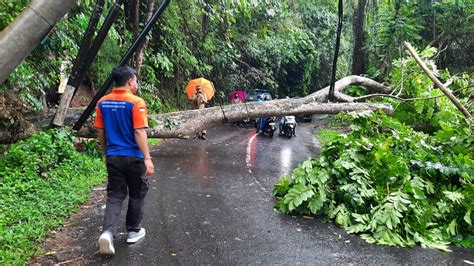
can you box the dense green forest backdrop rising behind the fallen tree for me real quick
[0,0,474,113]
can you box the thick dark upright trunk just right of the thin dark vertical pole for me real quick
[352,0,367,75]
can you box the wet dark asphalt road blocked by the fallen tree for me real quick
[77,123,474,265]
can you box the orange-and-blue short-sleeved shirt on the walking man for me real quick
[94,88,148,158]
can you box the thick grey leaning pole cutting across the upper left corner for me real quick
[0,0,76,84]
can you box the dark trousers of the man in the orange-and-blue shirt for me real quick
[102,156,149,235]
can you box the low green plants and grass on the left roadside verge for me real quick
[0,130,106,264]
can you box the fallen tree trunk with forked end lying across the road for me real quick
[0,76,393,143]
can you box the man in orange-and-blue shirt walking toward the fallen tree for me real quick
[94,66,155,255]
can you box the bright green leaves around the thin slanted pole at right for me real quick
[385,48,474,129]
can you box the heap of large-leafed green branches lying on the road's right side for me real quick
[273,112,474,250]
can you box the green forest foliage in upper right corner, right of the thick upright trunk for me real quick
[365,0,474,79]
